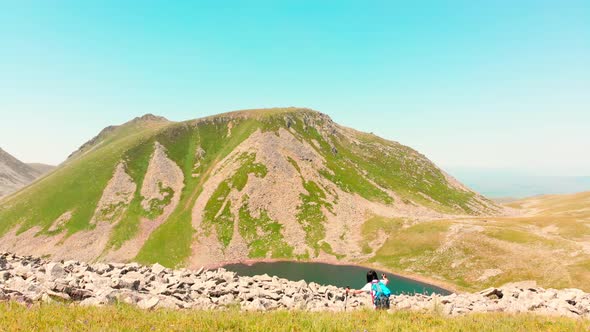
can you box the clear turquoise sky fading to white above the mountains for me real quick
[0,0,590,175]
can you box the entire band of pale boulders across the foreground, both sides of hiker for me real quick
[0,253,590,318]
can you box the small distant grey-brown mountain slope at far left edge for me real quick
[0,148,54,198]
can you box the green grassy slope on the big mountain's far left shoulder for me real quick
[0,119,166,239]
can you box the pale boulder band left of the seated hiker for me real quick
[0,253,369,311]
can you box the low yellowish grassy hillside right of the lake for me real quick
[366,192,590,291]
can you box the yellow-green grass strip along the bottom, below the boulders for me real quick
[0,303,590,331]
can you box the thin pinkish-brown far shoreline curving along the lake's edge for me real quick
[204,258,462,293]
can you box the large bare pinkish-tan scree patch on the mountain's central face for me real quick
[190,129,324,266]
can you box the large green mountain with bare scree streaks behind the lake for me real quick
[0,108,503,267]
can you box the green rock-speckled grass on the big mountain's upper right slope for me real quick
[278,110,488,214]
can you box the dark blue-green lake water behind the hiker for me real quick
[224,262,451,295]
